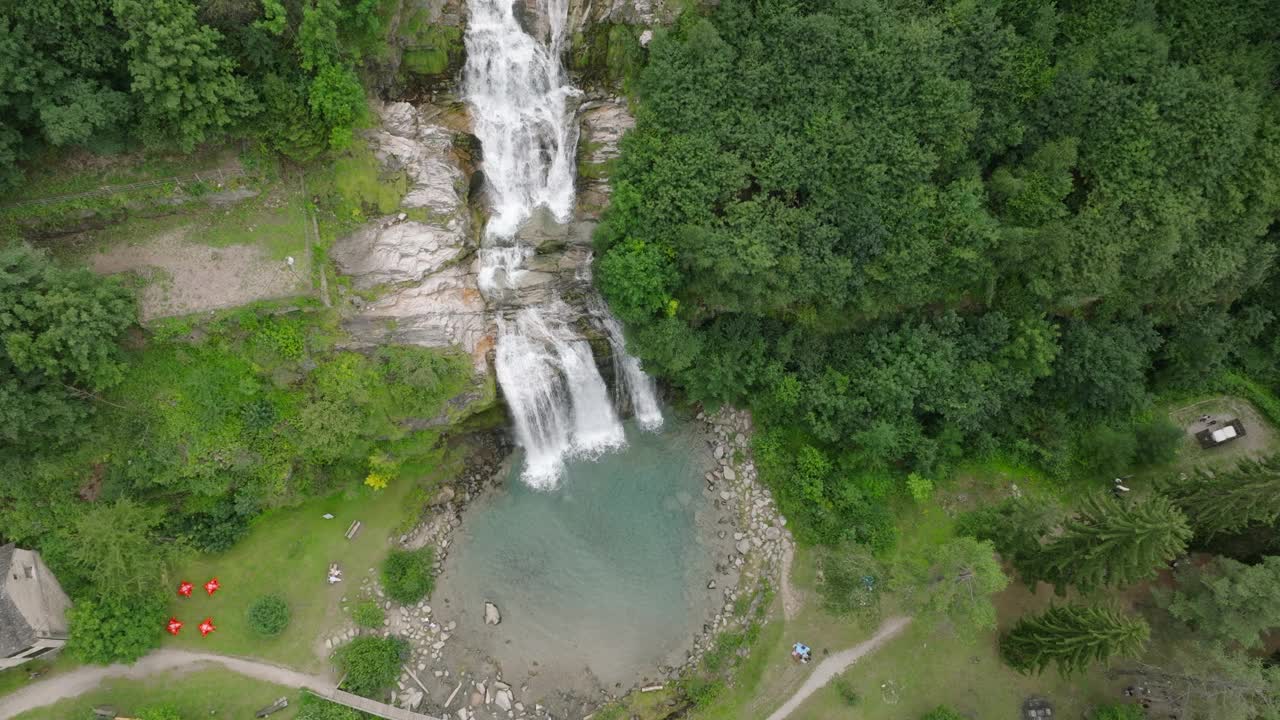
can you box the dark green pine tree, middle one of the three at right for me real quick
[1033,493,1192,594]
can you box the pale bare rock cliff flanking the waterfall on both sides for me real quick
[329,8,645,369]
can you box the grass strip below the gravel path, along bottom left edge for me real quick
[15,667,301,720]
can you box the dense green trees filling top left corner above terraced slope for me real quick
[0,0,384,190]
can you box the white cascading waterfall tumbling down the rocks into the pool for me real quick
[463,0,662,488]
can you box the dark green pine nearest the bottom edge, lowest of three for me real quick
[1000,605,1151,675]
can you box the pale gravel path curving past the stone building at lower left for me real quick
[0,650,335,720]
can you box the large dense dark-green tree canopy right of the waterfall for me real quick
[596,0,1280,542]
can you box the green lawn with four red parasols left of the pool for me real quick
[165,461,448,671]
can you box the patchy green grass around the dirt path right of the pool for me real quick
[691,459,1126,720]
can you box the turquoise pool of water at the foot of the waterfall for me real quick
[433,414,718,688]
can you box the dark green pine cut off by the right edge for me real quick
[1162,455,1280,537]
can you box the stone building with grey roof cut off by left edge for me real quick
[0,543,72,670]
